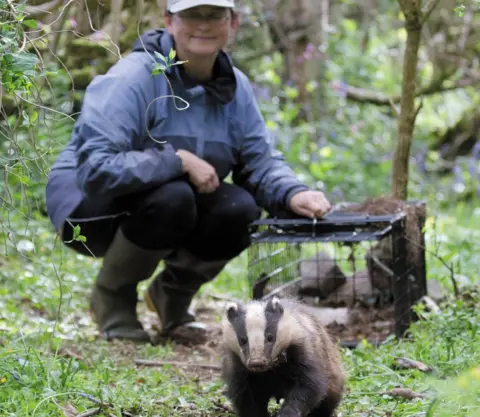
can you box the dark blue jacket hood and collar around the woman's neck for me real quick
[132,29,237,104]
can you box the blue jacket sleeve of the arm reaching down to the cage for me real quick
[232,77,310,215]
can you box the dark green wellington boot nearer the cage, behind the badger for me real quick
[145,250,228,335]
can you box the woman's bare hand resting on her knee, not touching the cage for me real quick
[177,149,220,193]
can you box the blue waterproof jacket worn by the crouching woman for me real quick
[46,29,308,230]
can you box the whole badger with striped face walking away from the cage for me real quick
[221,297,345,417]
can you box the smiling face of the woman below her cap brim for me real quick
[165,6,238,60]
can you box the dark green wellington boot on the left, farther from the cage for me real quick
[90,228,172,343]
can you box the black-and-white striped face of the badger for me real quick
[223,297,289,372]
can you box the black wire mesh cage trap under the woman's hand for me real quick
[248,211,426,344]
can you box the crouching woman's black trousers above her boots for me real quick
[62,179,261,261]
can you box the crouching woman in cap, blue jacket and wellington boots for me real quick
[46,0,330,341]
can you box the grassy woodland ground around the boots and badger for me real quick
[0,203,480,417]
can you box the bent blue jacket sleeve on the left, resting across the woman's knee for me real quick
[76,56,182,197]
